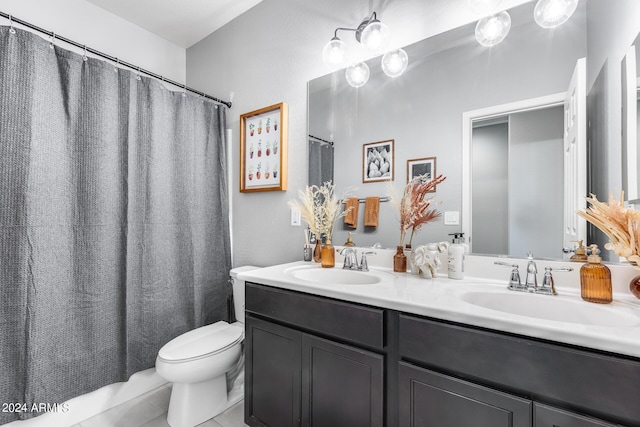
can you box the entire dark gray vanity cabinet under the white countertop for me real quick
[245,283,640,427]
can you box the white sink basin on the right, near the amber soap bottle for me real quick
[460,290,640,327]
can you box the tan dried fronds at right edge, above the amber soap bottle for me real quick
[578,194,640,268]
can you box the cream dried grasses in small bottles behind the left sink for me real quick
[289,181,353,244]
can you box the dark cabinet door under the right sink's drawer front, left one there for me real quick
[398,362,531,427]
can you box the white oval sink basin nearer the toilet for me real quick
[285,265,394,285]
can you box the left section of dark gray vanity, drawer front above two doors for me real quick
[245,283,385,427]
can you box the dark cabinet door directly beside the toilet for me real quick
[245,315,302,427]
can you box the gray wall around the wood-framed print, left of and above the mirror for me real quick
[187,0,526,266]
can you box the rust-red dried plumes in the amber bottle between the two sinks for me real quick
[389,174,447,246]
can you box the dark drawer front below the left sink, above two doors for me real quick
[245,283,384,349]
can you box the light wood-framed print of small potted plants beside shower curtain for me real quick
[240,102,289,193]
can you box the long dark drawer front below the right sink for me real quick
[400,314,640,426]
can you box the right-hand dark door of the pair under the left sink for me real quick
[302,334,384,427]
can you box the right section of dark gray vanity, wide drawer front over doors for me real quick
[399,314,640,427]
